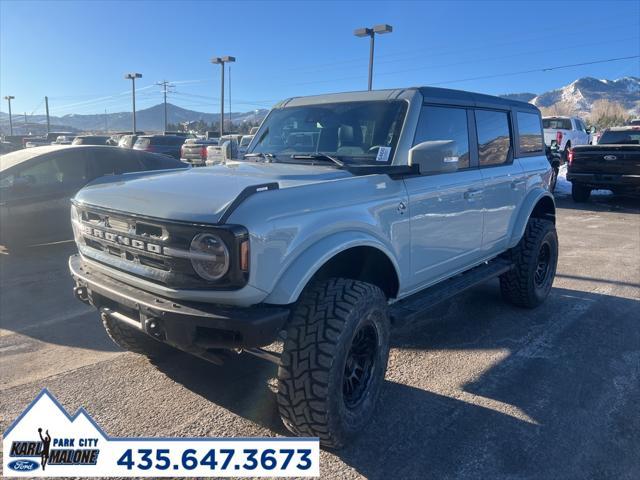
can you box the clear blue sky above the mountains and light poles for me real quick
[0,0,640,115]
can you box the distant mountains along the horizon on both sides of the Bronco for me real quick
[0,77,640,133]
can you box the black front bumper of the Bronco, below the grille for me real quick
[69,255,289,354]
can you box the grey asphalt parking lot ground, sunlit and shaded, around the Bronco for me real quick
[0,196,640,479]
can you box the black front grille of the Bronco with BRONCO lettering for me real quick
[75,205,248,289]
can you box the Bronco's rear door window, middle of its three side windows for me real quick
[475,110,512,167]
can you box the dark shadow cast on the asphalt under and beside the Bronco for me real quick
[155,283,640,479]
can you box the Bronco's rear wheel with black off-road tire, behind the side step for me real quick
[500,218,558,308]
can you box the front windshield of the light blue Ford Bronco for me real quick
[250,100,407,165]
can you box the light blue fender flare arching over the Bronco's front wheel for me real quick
[264,230,401,305]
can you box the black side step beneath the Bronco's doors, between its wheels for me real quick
[389,258,513,327]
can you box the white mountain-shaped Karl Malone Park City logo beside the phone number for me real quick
[3,389,105,473]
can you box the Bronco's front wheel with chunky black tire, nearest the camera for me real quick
[278,278,389,448]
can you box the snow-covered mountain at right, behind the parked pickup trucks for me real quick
[502,77,640,115]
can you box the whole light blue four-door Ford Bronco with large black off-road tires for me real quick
[69,88,558,447]
